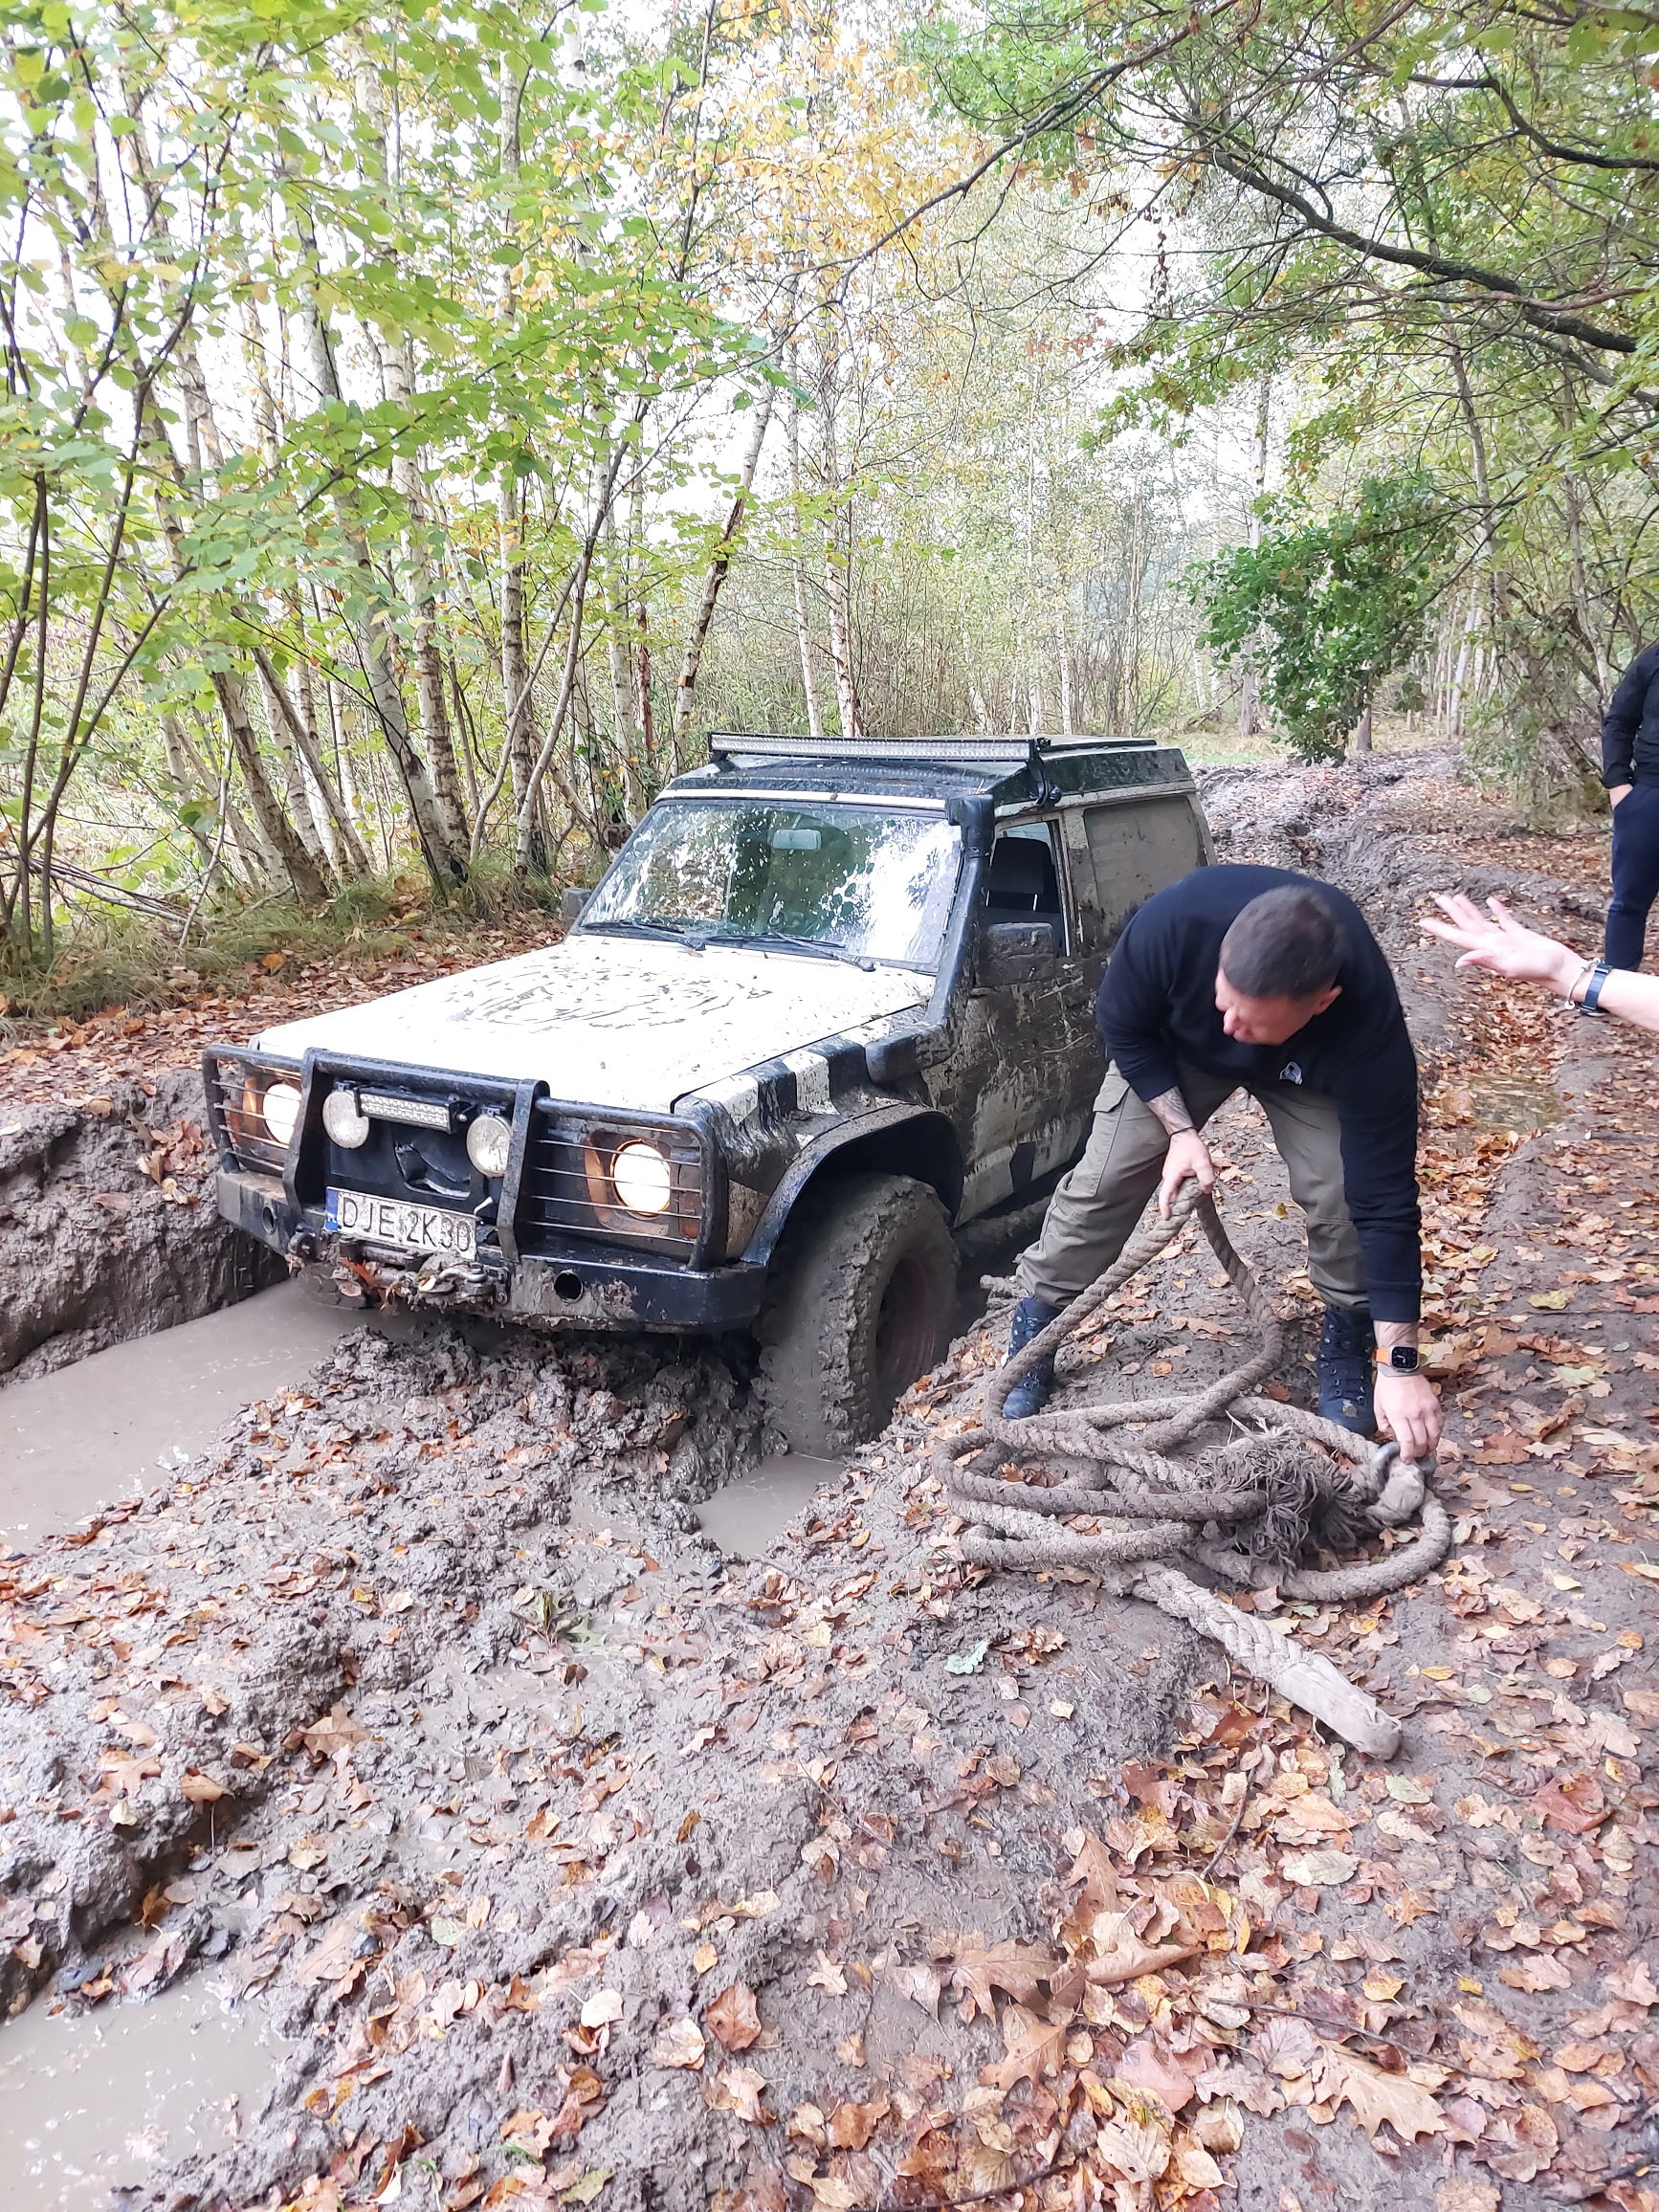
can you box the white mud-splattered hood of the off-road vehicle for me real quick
[256,934,934,1113]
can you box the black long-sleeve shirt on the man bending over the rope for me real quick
[1099,867,1423,1320]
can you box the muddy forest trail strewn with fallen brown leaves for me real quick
[0,757,1659,2212]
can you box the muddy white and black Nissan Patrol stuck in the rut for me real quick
[204,737,1210,1451]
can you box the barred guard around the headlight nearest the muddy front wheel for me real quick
[518,1104,703,1259]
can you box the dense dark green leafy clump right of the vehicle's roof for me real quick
[1192,476,1455,761]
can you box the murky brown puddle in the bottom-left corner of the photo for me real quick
[0,1978,283,2212]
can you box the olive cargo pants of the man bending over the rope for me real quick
[1015,1064,1365,1307]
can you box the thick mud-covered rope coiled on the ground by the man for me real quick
[936,1190,1451,1759]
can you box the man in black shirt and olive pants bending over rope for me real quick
[1006,867,1440,1460]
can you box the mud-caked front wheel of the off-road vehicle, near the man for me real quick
[759,1175,956,1458]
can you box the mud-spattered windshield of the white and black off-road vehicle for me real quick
[582,799,960,969]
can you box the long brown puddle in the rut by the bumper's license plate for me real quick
[0,1283,416,1544]
